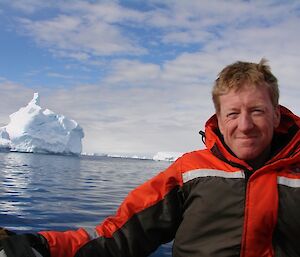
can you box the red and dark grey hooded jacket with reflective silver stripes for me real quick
[40,107,300,257]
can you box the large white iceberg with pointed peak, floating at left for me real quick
[0,93,84,155]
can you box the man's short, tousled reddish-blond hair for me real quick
[212,58,279,113]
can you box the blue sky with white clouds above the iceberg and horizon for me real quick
[0,0,300,155]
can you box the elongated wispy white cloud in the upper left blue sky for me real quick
[19,15,145,59]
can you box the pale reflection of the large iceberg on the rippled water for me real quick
[0,153,80,230]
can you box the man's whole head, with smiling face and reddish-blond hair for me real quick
[213,60,280,168]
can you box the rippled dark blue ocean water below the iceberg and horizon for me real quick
[0,153,171,257]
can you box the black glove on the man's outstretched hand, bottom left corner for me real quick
[0,234,50,257]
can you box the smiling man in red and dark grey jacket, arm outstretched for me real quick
[2,59,300,257]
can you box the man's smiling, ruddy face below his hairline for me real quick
[217,85,280,161]
